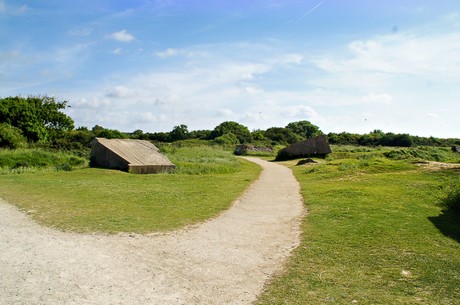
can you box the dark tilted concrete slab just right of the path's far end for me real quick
[276,135,332,161]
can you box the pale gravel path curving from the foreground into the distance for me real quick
[0,158,304,304]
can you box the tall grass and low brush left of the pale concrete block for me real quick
[0,149,88,174]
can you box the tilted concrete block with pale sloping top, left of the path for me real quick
[90,138,175,174]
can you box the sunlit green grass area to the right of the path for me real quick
[258,147,460,304]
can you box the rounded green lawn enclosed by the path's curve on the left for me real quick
[0,146,260,233]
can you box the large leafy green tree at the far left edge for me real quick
[0,96,74,142]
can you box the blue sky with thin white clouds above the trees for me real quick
[0,0,460,138]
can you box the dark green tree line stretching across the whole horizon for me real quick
[0,96,460,150]
